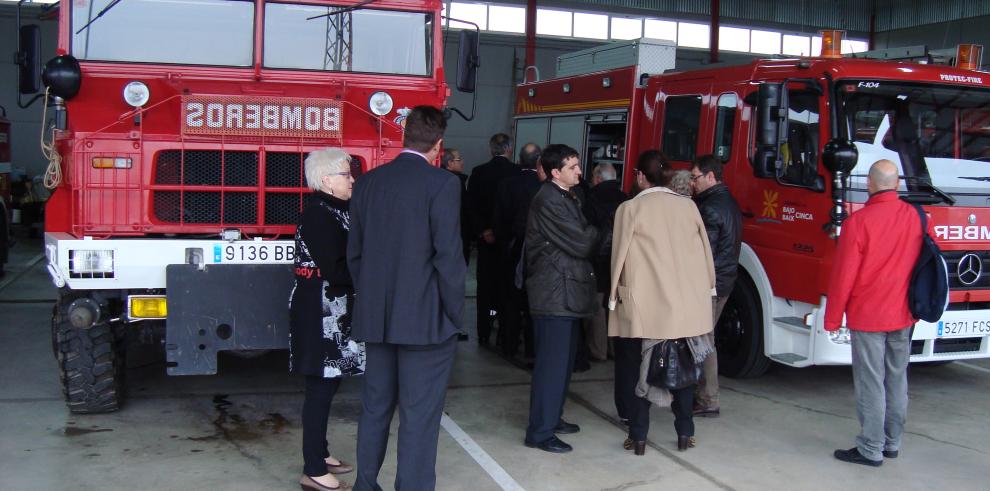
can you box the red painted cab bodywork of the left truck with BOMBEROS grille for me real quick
[46,0,449,238]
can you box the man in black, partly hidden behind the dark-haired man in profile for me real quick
[494,143,543,357]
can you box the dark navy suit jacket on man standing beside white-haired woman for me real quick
[347,152,467,345]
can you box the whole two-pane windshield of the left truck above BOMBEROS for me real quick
[72,0,433,76]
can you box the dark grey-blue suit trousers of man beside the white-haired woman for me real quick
[354,336,457,491]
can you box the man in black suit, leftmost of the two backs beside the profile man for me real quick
[468,133,519,346]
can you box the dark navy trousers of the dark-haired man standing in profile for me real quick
[526,317,581,443]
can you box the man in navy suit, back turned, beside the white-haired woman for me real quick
[347,106,467,490]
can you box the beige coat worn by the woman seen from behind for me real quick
[608,188,715,339]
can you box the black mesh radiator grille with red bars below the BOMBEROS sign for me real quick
[151,150,308,225]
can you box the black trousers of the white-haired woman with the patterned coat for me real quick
[303,375,340,477]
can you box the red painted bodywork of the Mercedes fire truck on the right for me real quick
[516,58,990,305]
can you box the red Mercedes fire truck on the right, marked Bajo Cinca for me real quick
[515,36,990,377]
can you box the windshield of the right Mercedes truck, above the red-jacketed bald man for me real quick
[839,81,990,206]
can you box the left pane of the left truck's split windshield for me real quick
[72,0,254,66]
